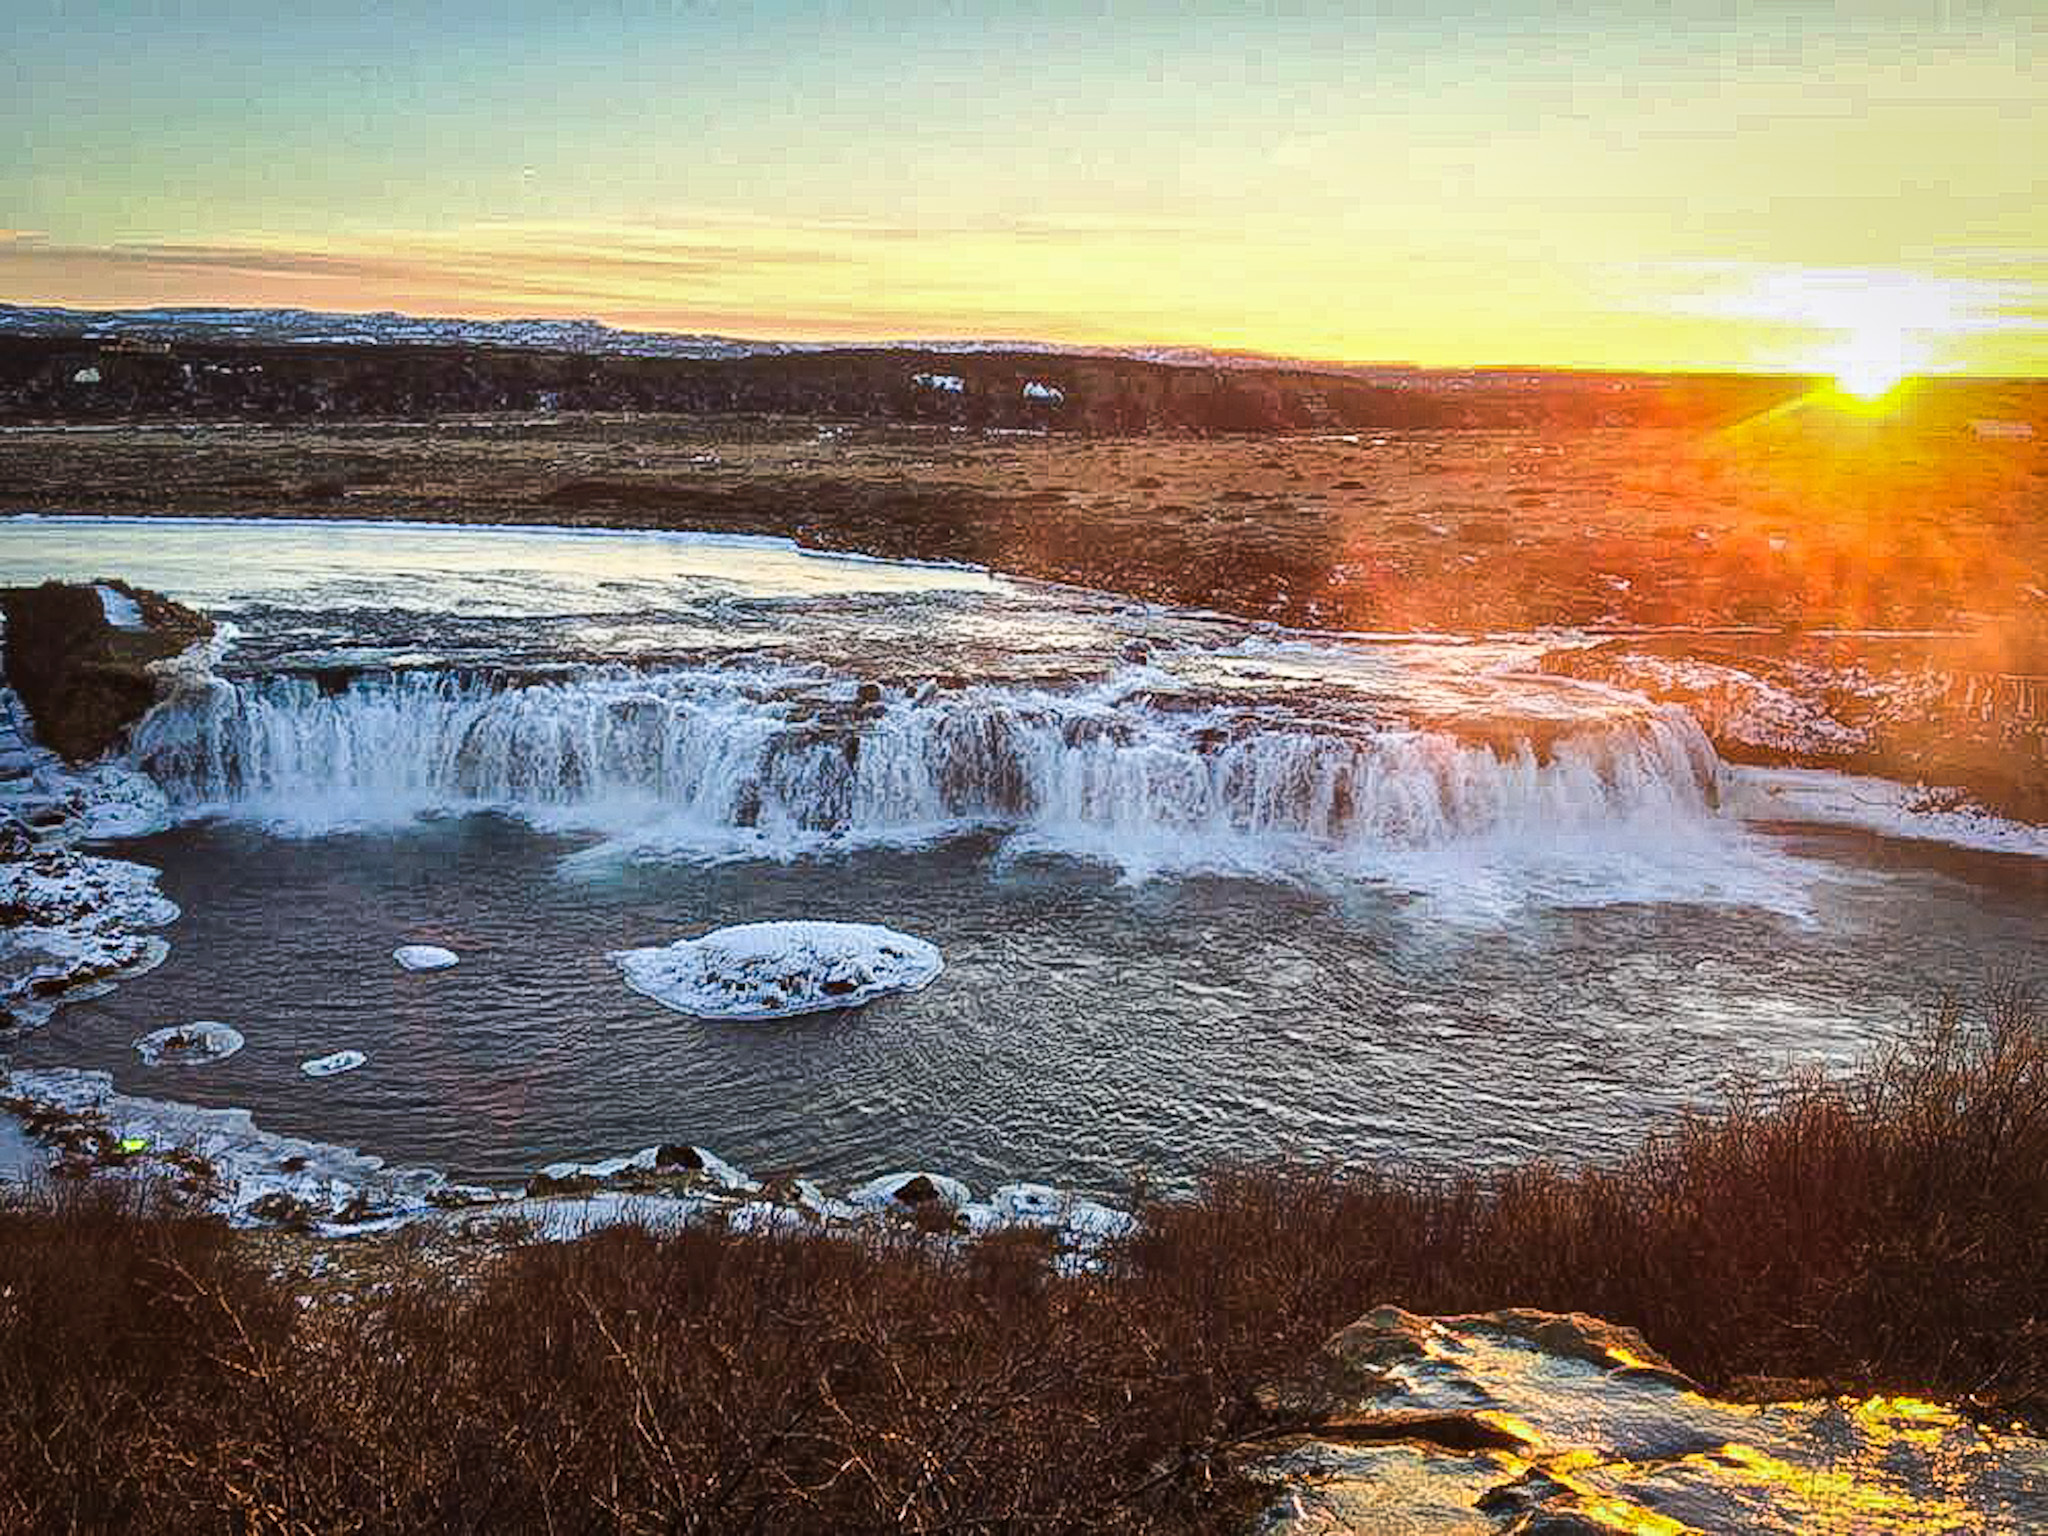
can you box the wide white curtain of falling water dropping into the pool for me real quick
[133,668,1718,864]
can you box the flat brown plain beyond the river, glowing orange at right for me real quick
[0,376,2048,819]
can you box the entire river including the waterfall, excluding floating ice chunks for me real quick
[0,520,2048,1190]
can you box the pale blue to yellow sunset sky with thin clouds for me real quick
[0,0,2048,375]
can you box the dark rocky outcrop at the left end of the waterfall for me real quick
[0,582,213,762]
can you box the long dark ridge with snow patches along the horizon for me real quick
[0,305,2042,434]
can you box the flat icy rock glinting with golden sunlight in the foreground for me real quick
[1257,1307,2048,1536]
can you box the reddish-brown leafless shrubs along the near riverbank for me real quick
[0,995,2048,1532]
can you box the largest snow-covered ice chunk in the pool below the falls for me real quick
[610,922,944,1018]
